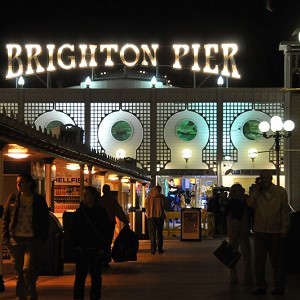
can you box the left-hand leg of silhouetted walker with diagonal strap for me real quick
[73,251,88,300]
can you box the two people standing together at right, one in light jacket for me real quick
[219,170,290,295]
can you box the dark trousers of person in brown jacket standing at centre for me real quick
[148,218,165,253]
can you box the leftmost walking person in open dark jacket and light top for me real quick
[2,173,50,300]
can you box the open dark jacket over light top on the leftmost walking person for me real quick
[2,192,50,244]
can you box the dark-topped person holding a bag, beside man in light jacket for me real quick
[224,183,253,285]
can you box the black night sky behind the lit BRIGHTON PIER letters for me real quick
[0,0,300,87]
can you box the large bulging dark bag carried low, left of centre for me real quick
[111,226,139,262]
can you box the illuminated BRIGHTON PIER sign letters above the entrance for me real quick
[6,43,241,79]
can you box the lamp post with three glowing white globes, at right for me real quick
[258,116,295,185]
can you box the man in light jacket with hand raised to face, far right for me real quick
[247,170,290,295]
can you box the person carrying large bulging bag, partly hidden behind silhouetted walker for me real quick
[99,184,129,267]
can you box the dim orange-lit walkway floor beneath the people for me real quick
[0,238,300,300]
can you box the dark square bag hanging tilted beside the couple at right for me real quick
[213,240,242,269]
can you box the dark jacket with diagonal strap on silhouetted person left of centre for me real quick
[71,203,110,249]
